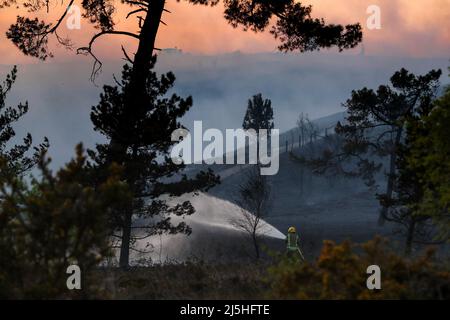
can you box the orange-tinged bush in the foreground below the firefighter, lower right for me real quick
[269,238,450,299]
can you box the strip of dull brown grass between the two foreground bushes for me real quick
[97,262,268,300]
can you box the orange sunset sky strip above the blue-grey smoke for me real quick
[0,0,450,64]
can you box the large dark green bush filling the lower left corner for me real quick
[0,145,130,299]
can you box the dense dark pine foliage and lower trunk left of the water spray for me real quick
[90,57,218,267]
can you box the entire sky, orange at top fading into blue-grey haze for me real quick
[0,0,450,169]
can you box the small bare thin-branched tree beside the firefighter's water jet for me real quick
[231,166,272,259]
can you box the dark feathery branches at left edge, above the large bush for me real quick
[0,66,48,179]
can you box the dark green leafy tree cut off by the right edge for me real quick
[382,77,450,254]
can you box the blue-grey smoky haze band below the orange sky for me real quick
[0,53,449,169]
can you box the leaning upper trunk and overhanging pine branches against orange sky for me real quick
[0,0,362,62]
